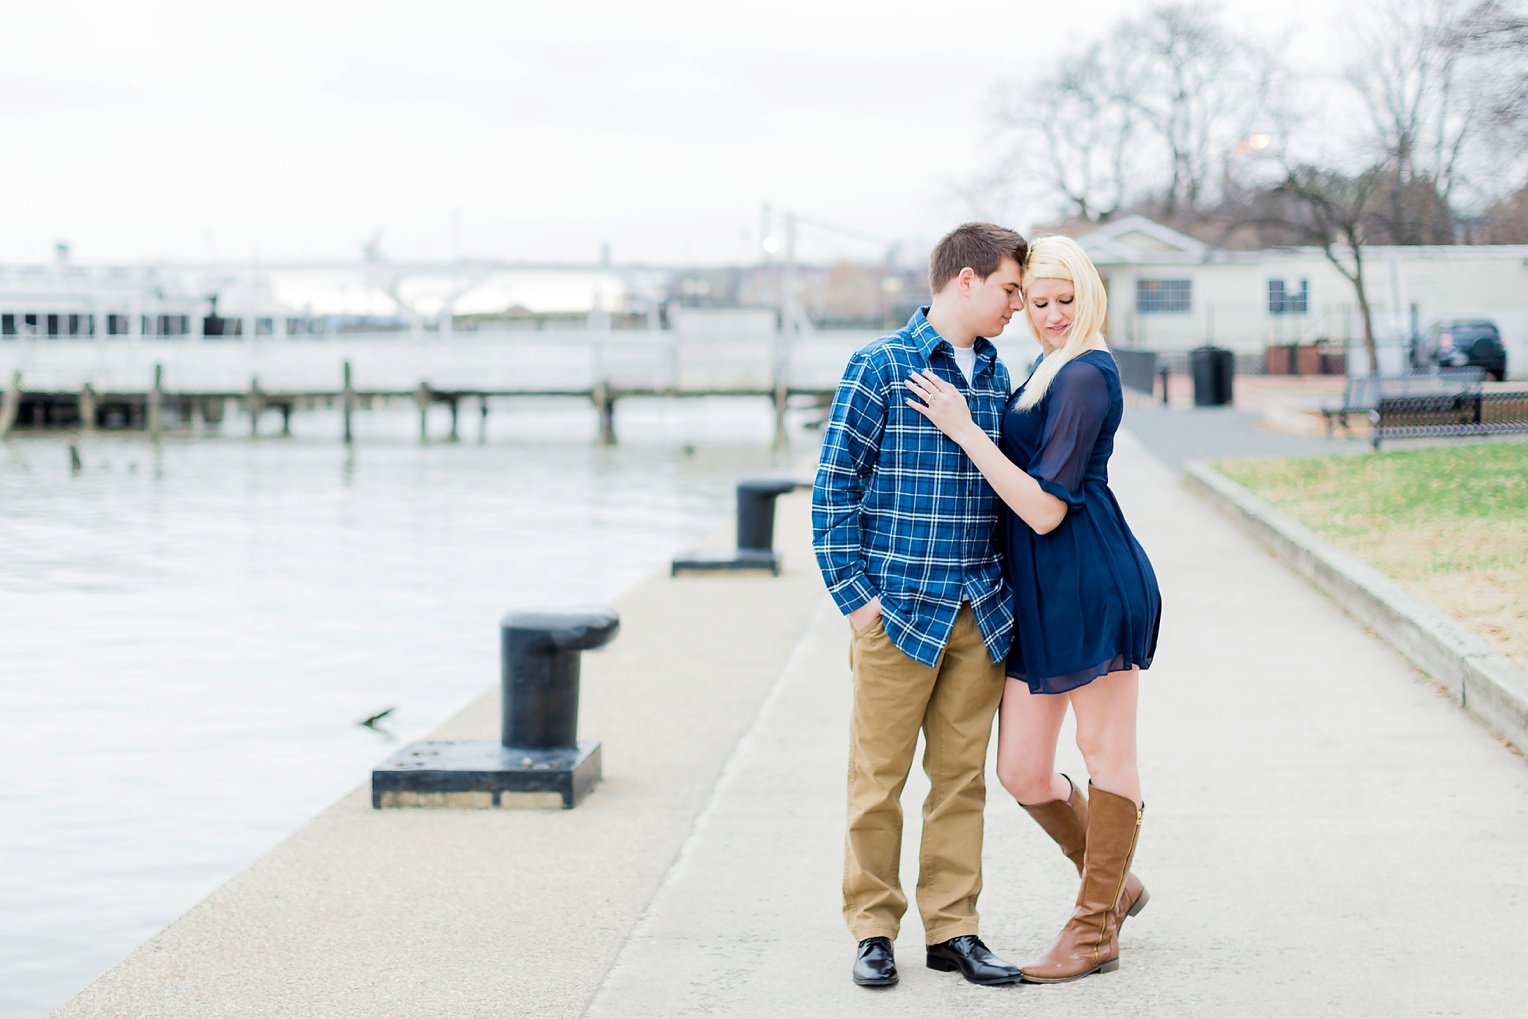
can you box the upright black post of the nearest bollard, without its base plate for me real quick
[498,608,620,750]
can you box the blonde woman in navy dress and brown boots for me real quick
[908,237,1161,984]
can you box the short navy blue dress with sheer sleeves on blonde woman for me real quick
[1002,350,1161,694]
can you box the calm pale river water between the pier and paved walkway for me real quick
[0,399,802,1019]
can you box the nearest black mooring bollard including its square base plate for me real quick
[371,608,620,810]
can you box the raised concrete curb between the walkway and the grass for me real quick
[1183,461,1528,750]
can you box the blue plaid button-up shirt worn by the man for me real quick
[811,309,1013,665]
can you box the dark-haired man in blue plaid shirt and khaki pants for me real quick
[811,223,1028,987]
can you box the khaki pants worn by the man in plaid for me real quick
[843,605,1004,944]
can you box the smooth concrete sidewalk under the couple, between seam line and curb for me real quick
[577,435,1528,1019]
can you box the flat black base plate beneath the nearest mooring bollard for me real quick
[371,739,601,810]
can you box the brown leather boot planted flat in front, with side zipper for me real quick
[1019,788,1143,984]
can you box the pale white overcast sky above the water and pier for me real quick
[0,0,1361,263]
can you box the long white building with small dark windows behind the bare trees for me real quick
[1077,215,1528,376]
